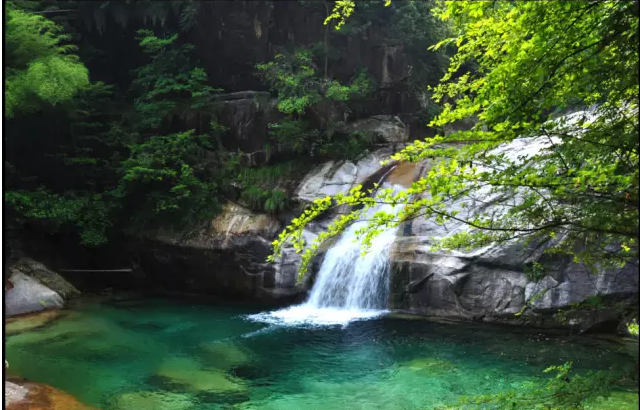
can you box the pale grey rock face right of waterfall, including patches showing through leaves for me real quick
[390,139,638,323]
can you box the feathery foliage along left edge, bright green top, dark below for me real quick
[4,2,117,245]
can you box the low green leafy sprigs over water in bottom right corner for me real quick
[433,362,616,410]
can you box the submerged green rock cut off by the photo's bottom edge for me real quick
[108,391,193,410]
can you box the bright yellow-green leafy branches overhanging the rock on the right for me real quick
[271,1,639,273]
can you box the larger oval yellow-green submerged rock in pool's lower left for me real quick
[154,357,249,396]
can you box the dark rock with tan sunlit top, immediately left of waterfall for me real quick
[139,202,301,301]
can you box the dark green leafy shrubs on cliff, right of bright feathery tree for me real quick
[119,30,224,230]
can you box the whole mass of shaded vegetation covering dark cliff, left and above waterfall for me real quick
[4,0,456,246]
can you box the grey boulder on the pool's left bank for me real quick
[5,258,79,316]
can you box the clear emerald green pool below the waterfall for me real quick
[5,299,637,410]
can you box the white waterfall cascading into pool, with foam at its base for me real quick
[249,185,396,325]
